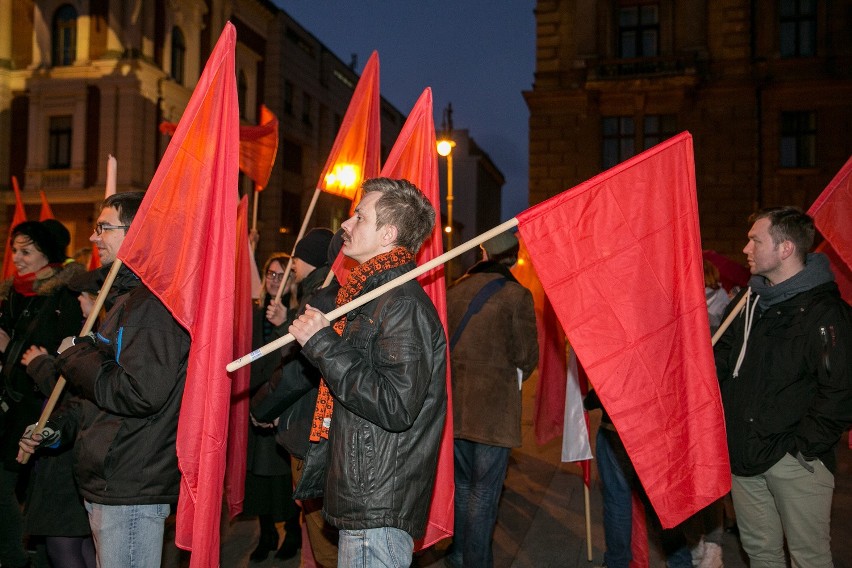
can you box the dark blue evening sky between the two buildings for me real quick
[275,0,535,220]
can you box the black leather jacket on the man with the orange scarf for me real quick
[302,263,447,539]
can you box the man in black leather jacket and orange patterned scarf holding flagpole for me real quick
[290,178,447,566]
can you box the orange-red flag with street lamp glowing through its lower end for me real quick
[317,51,381,203]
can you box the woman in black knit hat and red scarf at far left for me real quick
[0,219,83,568]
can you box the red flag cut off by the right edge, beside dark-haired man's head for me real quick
[808,157,852,276]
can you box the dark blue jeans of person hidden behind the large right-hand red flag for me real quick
[596,428,692,568]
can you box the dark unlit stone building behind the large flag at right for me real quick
[525,0,852,260]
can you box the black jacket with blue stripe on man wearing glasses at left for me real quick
[51,267,190,505]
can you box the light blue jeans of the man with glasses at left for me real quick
[85,501,170,568]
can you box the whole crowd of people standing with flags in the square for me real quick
[0,178,852,568]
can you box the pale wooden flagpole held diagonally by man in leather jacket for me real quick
[225,217,518,372]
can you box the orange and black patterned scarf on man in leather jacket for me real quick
[311,247,414,442]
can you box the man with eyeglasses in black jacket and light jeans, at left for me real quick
[19,192,190,568]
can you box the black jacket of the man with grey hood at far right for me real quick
[715,282,852,476]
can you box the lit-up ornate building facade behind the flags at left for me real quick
[0,0,405,260]
